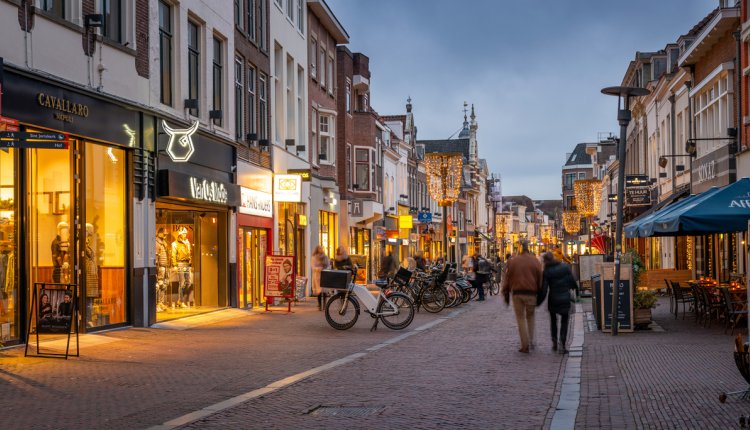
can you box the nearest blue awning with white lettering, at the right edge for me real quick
[639,178,750,236]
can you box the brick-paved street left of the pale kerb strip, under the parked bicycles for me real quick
[0,297,565,430]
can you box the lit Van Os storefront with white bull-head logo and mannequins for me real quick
[156,120,240,321]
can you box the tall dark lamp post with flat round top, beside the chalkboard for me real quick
[602,87,651,336]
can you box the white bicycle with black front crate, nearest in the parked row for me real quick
[320,270,414,331]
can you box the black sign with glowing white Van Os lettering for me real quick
[158,170,241,206]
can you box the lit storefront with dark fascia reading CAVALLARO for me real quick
[0,67,135,345]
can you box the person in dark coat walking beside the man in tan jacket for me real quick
[542,252,576,354]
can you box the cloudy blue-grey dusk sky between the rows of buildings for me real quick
[326,0,719,199]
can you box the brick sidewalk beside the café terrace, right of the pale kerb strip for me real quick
[576,298,750,430]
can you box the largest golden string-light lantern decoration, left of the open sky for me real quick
[425,152,464,206]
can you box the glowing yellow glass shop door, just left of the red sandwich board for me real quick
[240,228,268,307]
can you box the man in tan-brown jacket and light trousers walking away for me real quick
[501,242,542,353]
